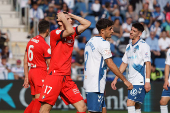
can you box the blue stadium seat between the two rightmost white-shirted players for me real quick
[155,58,165,70]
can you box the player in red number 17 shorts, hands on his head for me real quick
[39,12,91,113]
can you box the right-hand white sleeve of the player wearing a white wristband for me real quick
[141,43,151,62]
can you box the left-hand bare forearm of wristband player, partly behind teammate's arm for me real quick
[111,62,128,90]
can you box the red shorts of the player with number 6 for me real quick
[28,68,47,95]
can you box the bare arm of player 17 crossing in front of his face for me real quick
[57,12,75,37]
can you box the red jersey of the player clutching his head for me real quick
[48,27,79,75]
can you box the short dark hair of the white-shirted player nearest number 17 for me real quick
[96,18,113,33]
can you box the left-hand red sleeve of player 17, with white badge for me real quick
[50,29,64,41]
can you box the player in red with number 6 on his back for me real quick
[23,20,51,113]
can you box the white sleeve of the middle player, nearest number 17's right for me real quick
[99,41,112,60]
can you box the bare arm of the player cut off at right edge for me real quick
[163,64,169,90]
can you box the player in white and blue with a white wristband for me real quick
[111,23,151,113]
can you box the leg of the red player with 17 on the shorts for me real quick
[39,75,64,113]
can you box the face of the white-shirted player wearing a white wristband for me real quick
[130,27,142,40]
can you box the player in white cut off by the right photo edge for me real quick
[160,49,170,113]
